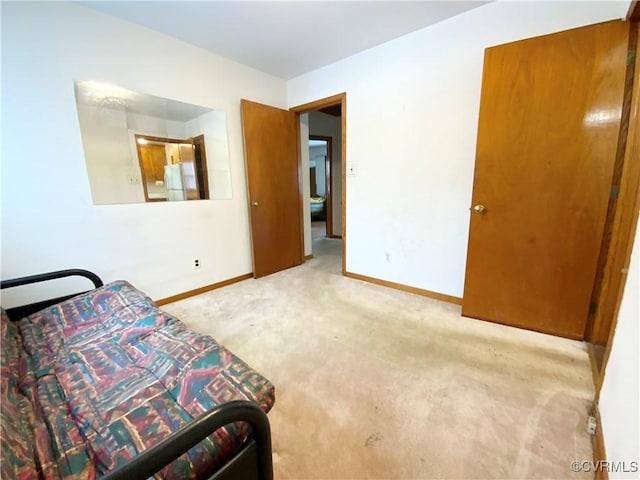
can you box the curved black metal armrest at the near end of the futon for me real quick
[102,400,273,480]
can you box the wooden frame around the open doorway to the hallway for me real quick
[289,92,347,275]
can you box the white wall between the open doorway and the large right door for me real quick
[287,2,629,297]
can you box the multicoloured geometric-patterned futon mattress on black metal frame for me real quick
[0,281,275,480]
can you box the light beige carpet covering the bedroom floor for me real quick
[163,234,594,479]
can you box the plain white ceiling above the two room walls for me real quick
[78,0,488,80]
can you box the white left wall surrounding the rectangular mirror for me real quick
[1,2,286,306]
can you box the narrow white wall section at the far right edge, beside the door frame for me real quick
[599,220,640,480]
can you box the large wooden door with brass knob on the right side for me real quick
[462,22,628,339]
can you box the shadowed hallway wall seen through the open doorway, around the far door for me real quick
[309,112,342,235]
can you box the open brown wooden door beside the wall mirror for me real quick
[241,100,304,278]
